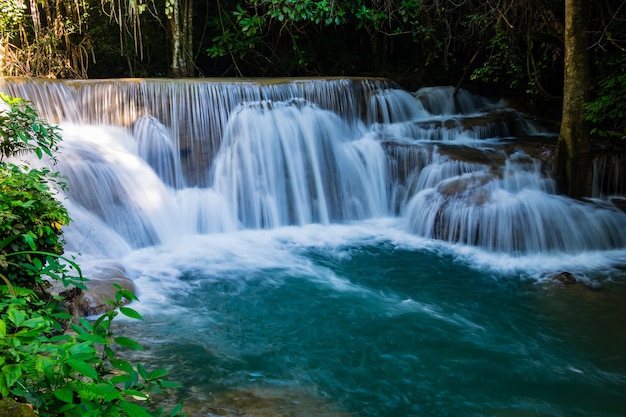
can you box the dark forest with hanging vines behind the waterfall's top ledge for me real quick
[0,0,626,138]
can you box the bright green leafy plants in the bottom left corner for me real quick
[0,286,181,417]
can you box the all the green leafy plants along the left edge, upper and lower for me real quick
[0,97,182,417]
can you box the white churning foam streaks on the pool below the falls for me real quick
[114,218,626,314]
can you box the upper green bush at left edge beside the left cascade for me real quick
[0,95,69,287]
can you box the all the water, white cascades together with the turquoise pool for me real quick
[0,79,626,417]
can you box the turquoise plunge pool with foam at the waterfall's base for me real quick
[118,222,626,417]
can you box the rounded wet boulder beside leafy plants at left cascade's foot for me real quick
[48,259,135,317]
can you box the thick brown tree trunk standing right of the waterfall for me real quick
[557,0,592,198]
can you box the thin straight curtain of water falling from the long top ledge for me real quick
[0,78,390,186]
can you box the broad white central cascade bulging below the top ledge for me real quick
[214,100,387,228]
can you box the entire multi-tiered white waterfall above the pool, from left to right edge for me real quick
[0,78,626,257]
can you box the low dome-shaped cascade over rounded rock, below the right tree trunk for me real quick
[406,154,626,253]
